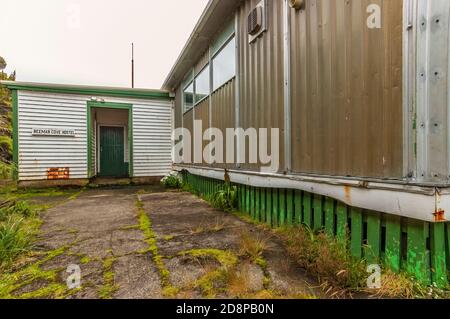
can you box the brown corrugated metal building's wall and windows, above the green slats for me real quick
[163,0,450,220]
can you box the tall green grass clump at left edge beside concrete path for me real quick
[0,216,31,265]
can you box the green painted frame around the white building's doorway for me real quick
[87,101,134,178]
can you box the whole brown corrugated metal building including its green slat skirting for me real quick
[163,0,450,284]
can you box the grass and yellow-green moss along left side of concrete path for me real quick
[0,187,83,299]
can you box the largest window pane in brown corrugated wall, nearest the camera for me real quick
[212,38,236,90]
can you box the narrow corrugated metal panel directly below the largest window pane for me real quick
[211,79,236,168]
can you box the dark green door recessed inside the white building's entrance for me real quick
[100,126,128,177]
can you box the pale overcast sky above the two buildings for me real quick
[0,0,208,89]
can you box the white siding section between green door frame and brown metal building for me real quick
[133,101,172,177]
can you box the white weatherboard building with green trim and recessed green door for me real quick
[2,82,173,185]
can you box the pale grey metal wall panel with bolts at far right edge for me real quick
[416,0,450,183]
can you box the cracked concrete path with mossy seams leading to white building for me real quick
[7,187,315,298]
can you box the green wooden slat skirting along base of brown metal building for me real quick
[183,172,450,288]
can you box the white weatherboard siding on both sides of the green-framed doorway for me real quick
[18,91,172,181]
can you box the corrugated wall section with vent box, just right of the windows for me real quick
[236,0,284,171]
